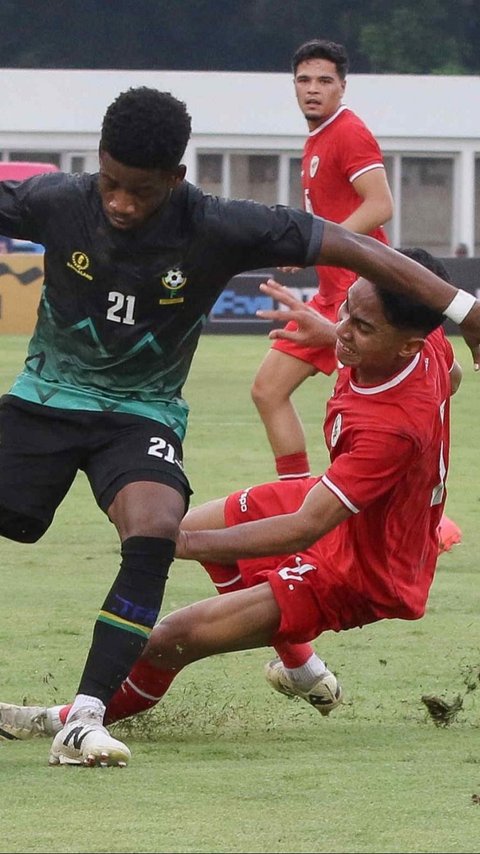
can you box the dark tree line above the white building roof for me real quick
[0,0,480,74]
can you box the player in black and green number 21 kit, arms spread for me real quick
[0,87,480,765]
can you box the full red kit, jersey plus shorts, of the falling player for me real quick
[225,328,454,642]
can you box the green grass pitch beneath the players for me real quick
[0,336,480,854]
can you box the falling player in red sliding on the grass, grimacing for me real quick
[144,278,461,712]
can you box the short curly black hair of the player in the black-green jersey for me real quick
[100,86,192,172]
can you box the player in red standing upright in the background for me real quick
[252,39,393,479]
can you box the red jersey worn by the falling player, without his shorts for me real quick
[318,328,454,619]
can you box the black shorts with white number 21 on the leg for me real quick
[0,395,192,542]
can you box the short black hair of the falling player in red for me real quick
[375,247,451,335]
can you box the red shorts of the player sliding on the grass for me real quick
[225,484,382,644]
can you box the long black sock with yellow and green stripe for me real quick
[77,537,175,705]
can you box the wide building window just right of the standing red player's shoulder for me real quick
[400,156,453,257]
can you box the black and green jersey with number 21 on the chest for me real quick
[0,173,323,437]
